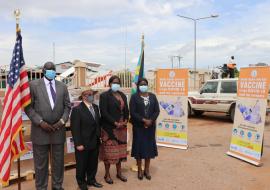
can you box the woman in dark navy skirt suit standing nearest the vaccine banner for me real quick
[129,78,160,180]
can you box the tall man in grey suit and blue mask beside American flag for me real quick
[25,62,71,190]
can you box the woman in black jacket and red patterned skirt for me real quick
[99,76,129,184]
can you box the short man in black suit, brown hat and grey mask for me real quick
[70,88,102,190]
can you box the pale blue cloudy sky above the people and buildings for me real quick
[0,0,270,70]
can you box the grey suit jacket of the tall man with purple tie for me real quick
[25,78,71,145]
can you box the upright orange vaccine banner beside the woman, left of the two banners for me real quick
[156,69,188,149]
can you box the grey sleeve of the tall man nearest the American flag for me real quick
[24,83,42,126]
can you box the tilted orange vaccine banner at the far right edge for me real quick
[227,67,270,165]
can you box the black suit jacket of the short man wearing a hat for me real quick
[70,102,100,150]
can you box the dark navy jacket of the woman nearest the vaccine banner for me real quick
[129,93,160,127]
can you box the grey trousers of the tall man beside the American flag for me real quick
[33,144,64,190]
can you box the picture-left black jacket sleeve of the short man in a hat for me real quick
[70,108,82,146]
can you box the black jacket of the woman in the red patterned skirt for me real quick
[99,89,129,129]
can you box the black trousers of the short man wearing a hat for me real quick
[75,147,99,186]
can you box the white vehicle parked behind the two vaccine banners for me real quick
[188,78,270,121]
